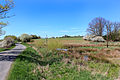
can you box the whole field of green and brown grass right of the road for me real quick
[8,38,120,80]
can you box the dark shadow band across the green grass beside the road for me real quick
[17,51,62,66]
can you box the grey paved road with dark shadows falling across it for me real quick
[0,44,26,80]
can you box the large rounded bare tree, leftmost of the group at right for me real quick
[87,17,106,36]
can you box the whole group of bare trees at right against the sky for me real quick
[87,17,120,41]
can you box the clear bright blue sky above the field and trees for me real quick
[3,0,120,37]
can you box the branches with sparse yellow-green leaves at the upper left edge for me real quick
[0,0,14,36]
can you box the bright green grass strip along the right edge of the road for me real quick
[8,48,39,80]
